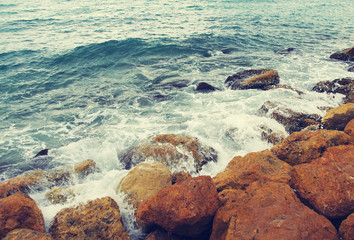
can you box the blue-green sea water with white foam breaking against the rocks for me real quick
[0,0,354,238]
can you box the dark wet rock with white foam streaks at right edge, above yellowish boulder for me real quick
[312,78,354,103]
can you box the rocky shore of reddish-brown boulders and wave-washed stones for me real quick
[0,48,354,240]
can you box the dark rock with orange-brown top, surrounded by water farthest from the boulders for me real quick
[225,69,279,90]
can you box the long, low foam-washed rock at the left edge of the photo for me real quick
[0,160,99,198]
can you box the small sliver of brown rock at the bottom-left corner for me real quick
[3,228,54,240]
